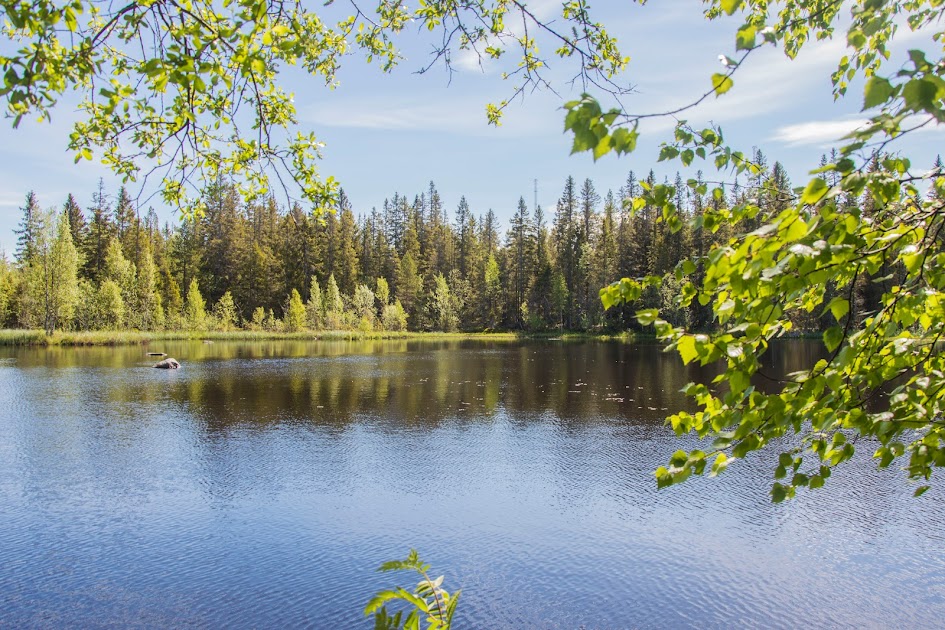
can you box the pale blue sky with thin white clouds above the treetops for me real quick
[0,0,943,253]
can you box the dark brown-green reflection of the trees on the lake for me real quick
[0,340,736,431]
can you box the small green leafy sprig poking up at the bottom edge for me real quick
[364,549,460,630]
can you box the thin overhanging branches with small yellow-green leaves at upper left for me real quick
[0,0,627,215]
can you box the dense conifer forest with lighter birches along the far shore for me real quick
[0,150,941,333]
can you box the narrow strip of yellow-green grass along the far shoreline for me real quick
[0,329,635,347]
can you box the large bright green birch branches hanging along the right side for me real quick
[592,0,945,501]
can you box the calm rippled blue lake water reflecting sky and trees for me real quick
[0,341,945,628]
